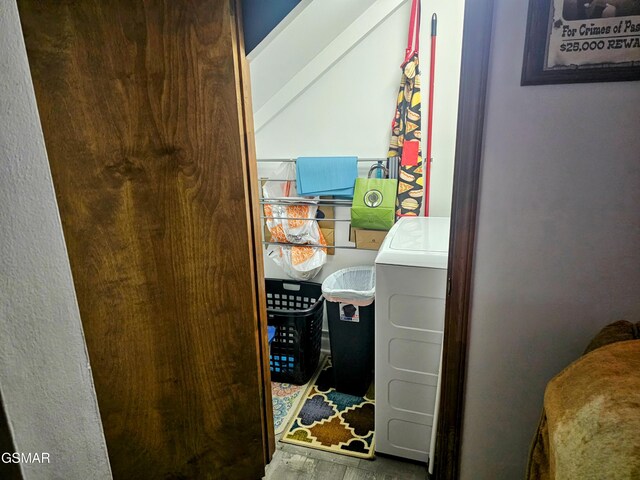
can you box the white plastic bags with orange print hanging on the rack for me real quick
[262,162,327,280]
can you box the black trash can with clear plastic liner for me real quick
[322,267,375,397]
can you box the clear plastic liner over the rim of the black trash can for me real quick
[322,266,376,307]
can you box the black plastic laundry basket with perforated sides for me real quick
[266,278,324,385]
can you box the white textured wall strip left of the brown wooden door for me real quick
[0,0,111,480]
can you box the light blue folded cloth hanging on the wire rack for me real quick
[296,157,358,198]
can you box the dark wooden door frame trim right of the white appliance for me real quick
[433,0,494,479]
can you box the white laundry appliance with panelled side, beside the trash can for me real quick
[375,217,450,470]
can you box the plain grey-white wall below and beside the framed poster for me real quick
[461,0,640,480]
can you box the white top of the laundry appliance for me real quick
[376,217,450,269]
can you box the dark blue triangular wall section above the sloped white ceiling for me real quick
[242,0,300,53]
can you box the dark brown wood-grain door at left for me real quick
[18,0,271,480]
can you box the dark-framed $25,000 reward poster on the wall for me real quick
[520,0,640,85]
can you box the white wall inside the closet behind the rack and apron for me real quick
[250,0,464,282]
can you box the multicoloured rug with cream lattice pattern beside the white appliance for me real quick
[280,359,375,458]
